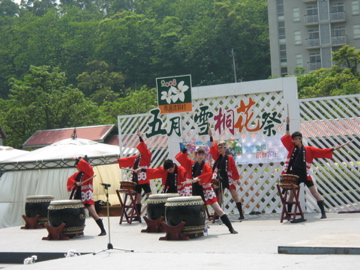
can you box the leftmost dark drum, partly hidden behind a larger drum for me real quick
[25,195,54,227]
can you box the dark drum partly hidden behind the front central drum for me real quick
[147,193,180,220]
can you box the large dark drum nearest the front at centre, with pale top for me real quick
[165,196,205,237]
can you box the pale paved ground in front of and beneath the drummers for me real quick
[0,213,360,270]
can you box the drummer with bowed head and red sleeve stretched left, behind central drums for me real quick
[135,159,190,196]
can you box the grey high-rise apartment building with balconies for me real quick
[268,0,360,77]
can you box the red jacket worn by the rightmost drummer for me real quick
[281,135,332,181]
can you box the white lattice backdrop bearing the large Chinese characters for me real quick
[118,78,299,213]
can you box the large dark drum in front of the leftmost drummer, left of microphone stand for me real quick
[48,200,85,238]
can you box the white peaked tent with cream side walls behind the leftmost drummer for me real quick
[0,139,136,228]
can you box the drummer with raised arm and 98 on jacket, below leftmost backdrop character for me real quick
[118,131,152,217]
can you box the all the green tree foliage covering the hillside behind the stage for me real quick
[0,0,359,147]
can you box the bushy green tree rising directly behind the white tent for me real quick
[1,66,100,147]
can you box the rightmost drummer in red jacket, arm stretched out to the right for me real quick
[281,117,342,219]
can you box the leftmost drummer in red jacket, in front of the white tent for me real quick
[67,156,106,236]
